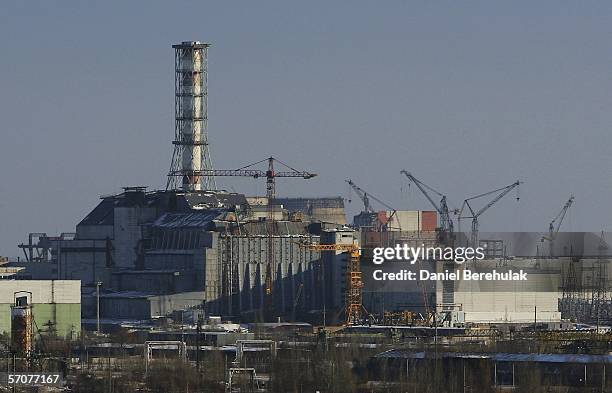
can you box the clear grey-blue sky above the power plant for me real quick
[0,0,612,256]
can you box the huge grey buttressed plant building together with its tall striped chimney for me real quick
[6,41,360,319]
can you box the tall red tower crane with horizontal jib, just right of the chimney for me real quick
[195,157,317,317]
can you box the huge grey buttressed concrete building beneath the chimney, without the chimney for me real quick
[16,187,353,319]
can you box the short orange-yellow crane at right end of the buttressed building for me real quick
[299,243,367,325]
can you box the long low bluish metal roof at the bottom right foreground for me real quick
[376,349,612,364]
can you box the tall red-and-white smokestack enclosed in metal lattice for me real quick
[166,41,217,191]
